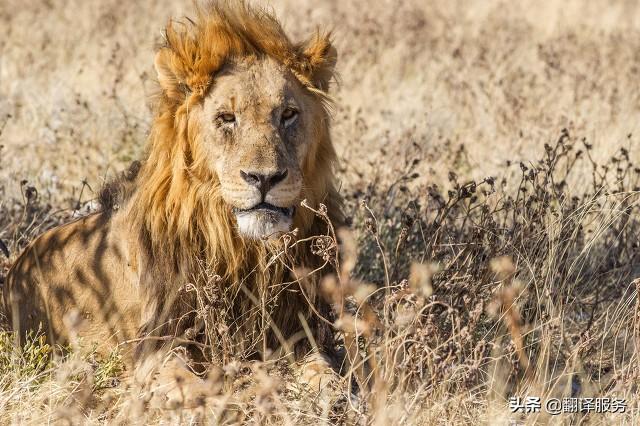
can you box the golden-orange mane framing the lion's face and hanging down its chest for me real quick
[130,1,343,358]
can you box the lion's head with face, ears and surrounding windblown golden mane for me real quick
[131,1,340,276]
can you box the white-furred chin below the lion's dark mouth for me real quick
[234,206,293,240]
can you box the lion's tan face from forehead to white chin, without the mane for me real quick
[199,58,319,238]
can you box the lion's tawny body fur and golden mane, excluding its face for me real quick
[5,2,343,370]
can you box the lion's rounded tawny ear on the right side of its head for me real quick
[301,32,338,91]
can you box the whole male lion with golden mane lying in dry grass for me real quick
[4,2,343,406]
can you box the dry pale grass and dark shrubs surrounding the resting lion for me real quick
[0,0,640,424]
